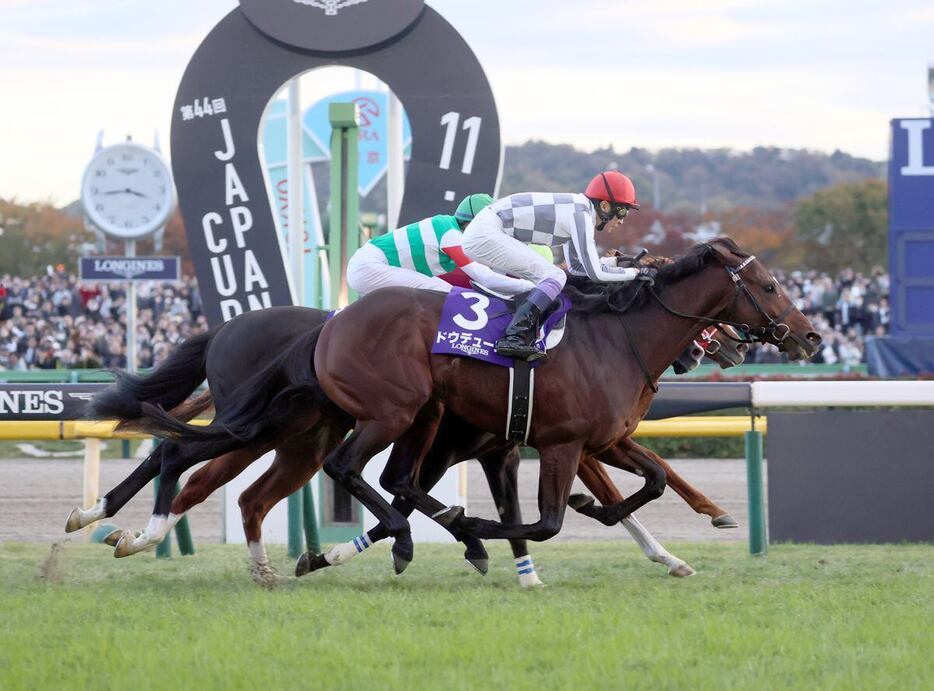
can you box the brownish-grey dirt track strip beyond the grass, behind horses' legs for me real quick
[0,459,747,544]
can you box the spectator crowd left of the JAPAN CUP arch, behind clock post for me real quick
[0,271,207,371]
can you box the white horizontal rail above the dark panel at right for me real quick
[752,381,934,408]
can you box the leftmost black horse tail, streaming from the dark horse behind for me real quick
[85,329,218,426]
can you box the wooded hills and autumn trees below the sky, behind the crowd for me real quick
[0,141,888,276]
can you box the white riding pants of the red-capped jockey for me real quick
[462,215,567,288]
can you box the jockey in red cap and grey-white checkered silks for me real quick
[464,171,655,360]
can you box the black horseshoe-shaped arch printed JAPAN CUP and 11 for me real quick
[172,0,502,325]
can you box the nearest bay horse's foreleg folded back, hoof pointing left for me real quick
[454,441,582,542]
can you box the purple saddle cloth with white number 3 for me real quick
[431,288,571,367]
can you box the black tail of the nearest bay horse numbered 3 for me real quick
[133,326,340,444]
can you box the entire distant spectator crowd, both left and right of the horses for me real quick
[0,268,891,371]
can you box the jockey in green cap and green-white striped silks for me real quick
[347,194,534,295]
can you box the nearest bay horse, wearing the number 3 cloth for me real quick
[308,238,821,572]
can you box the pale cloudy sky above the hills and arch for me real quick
[0,0,934,204]
